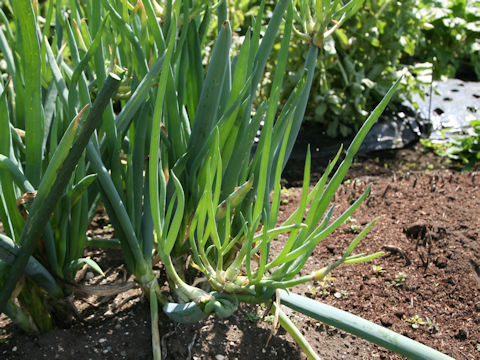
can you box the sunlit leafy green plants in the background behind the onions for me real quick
[225,0,480,138]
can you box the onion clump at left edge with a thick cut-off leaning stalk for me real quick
[0,0,121,333]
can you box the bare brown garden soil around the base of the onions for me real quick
[0,142,480,360]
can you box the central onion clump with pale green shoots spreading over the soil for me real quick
[75,1,404,356]
